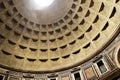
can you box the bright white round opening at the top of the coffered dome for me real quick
[33,0,54,9]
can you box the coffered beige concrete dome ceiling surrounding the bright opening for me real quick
[0,0,120,71]
